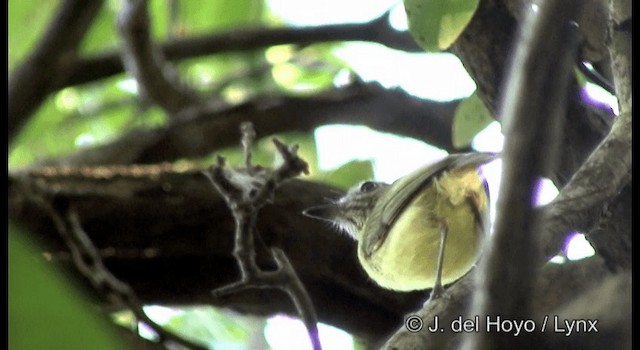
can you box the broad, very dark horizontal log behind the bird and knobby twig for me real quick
[9,165,425,342]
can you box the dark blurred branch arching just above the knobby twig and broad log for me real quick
[36,84,460,165]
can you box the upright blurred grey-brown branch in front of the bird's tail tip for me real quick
[464,1,580,349]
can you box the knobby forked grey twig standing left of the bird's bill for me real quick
[203,123,321,349]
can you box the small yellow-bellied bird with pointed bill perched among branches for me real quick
[303,153,498,298]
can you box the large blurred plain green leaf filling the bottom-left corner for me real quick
[9,224,127,350]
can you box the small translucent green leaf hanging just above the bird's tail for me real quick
[451,93,494,148]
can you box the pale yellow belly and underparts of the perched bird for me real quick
[358,167,488,291]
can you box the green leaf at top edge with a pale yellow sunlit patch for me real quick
[404,0,479,51]
